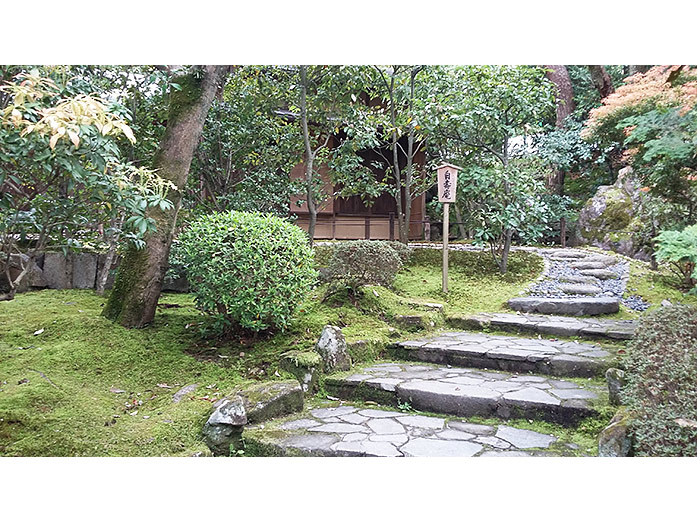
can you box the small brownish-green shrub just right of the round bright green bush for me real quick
[325,240,408,295]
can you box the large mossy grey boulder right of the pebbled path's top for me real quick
[575,167,651,261]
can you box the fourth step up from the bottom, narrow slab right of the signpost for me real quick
[446,312,636,340]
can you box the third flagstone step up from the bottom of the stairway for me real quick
[389,332,615,378]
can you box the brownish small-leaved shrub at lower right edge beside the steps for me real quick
[623,305,697,456]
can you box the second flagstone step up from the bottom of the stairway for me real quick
[324,362,607,425]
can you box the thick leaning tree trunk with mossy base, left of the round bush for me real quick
[103,65,227,327]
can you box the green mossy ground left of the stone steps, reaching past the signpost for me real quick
[0,251,541,456]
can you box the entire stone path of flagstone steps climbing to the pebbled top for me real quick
[239,249,635,457]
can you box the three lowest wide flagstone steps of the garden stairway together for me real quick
[245,331,615,457]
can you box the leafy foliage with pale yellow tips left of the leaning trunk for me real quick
[0,70,172,296]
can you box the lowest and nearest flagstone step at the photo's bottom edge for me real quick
[244,405,577,457]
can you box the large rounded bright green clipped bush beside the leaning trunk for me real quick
[179,211,317,332]
